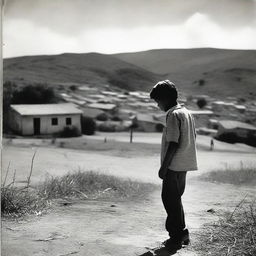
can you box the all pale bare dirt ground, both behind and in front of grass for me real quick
[2,135,256,256]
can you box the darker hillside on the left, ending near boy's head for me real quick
[4,53,161,90]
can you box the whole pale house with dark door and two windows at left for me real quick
[9,103,83,135]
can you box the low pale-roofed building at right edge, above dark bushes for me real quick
[217,120,256,138]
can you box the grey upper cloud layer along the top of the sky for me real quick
[5,0,255,34]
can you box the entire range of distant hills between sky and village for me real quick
[4,48,256,99]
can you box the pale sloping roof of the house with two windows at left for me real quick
[11,103,83,116]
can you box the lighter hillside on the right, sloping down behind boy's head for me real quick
[114,48,256,99]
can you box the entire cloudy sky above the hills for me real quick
[3,0,256,57]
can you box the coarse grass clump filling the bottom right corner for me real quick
[194,200,256,256]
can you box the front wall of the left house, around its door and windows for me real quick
[21,114,81,135]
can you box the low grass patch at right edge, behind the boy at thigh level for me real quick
[200,164,256,186]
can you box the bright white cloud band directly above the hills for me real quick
[3,13,256,57]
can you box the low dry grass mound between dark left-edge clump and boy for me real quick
[38,170,156,199]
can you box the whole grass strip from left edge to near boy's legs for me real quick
[1,170,157,217]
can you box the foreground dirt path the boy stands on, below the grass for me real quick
[2,180,255,256]
